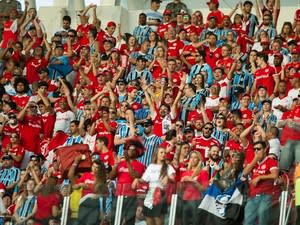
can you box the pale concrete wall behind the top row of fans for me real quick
[38,0,297,36]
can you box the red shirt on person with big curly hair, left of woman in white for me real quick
[116,160,145,196]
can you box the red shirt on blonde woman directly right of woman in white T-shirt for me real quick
[181,170,209,201]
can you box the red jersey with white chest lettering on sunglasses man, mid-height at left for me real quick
[20,115,43,155]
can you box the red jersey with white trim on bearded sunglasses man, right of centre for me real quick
[192,136,220,162]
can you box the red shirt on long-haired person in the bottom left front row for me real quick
[34,193,59,225]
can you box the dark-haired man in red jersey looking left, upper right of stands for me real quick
[251,53,279,97]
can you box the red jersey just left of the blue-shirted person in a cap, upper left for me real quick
[26,57,48,84]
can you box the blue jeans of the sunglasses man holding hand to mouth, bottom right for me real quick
[244,194,272,225]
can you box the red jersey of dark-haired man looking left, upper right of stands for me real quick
[254,65,275,96]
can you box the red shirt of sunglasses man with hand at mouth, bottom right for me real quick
[249,156,278,197]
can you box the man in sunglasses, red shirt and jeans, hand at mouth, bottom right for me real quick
[243,141,279,225]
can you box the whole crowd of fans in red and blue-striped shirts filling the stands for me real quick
[0,0,300,225]
